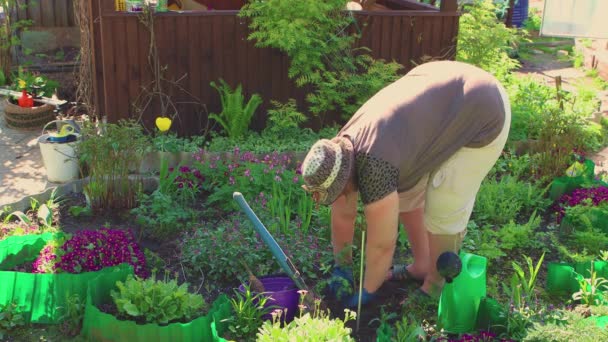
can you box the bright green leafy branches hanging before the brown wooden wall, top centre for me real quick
[239,0,354,85]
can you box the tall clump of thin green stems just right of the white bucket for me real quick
[77,121,150,210]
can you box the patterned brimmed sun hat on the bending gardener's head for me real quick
[302,137,354,205]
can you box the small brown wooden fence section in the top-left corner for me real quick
[17,0,75,27]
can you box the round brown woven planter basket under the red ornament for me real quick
[4,99,57,130]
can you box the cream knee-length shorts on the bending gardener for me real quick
[399,87,511,234]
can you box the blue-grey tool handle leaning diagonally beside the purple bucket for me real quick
[232,192,308,291]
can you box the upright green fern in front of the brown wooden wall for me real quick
[209,79,263,138]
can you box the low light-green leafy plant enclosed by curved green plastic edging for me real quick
[111,271,206,325]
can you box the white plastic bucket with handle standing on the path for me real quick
[38,121,80,183]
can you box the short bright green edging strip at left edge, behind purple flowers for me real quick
[0,233,54,271]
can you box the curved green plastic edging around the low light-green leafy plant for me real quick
[82,274,232,342]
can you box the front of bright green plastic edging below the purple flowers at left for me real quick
[0,264,133,324]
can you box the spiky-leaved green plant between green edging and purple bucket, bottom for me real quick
[226,284,274,341]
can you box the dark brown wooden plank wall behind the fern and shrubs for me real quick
[90,0,459,135]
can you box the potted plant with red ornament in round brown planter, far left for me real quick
[4,68,59,130]
